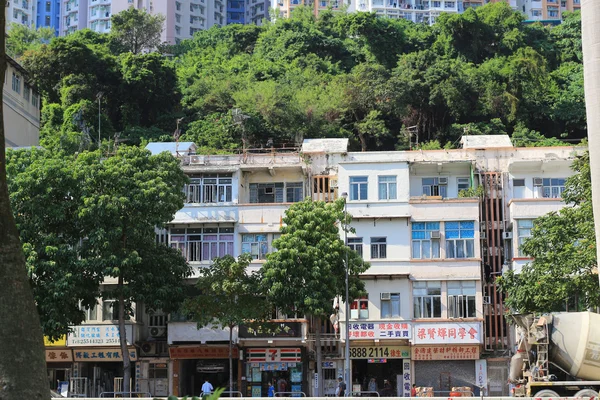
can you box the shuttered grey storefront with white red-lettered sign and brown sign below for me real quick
[411,322,481,397]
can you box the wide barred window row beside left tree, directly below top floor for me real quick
[169,228,233,262]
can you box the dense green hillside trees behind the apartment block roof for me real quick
[17,2,586,152]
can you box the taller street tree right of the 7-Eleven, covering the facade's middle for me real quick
[262,199,369,396]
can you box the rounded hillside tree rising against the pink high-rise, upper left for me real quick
[110,7,165,54]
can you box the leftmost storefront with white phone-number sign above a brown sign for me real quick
[67,324,137,397]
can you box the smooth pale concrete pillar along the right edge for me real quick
[581,0,600,290]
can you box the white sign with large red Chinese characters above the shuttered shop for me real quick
[414,322,481,344]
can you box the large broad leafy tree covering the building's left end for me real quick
[9,147,190,392]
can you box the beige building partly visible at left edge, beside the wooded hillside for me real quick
[2,56,41,147]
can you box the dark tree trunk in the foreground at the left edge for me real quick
[0,0,50,400]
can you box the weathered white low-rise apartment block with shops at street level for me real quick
[48,135,583,397]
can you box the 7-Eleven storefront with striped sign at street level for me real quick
[244,347,306,397]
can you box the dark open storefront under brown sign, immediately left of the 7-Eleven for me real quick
[169,345,240,397]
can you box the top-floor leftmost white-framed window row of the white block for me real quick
[183,174,233,203]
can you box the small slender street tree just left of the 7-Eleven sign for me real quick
[183,254,271,390]
